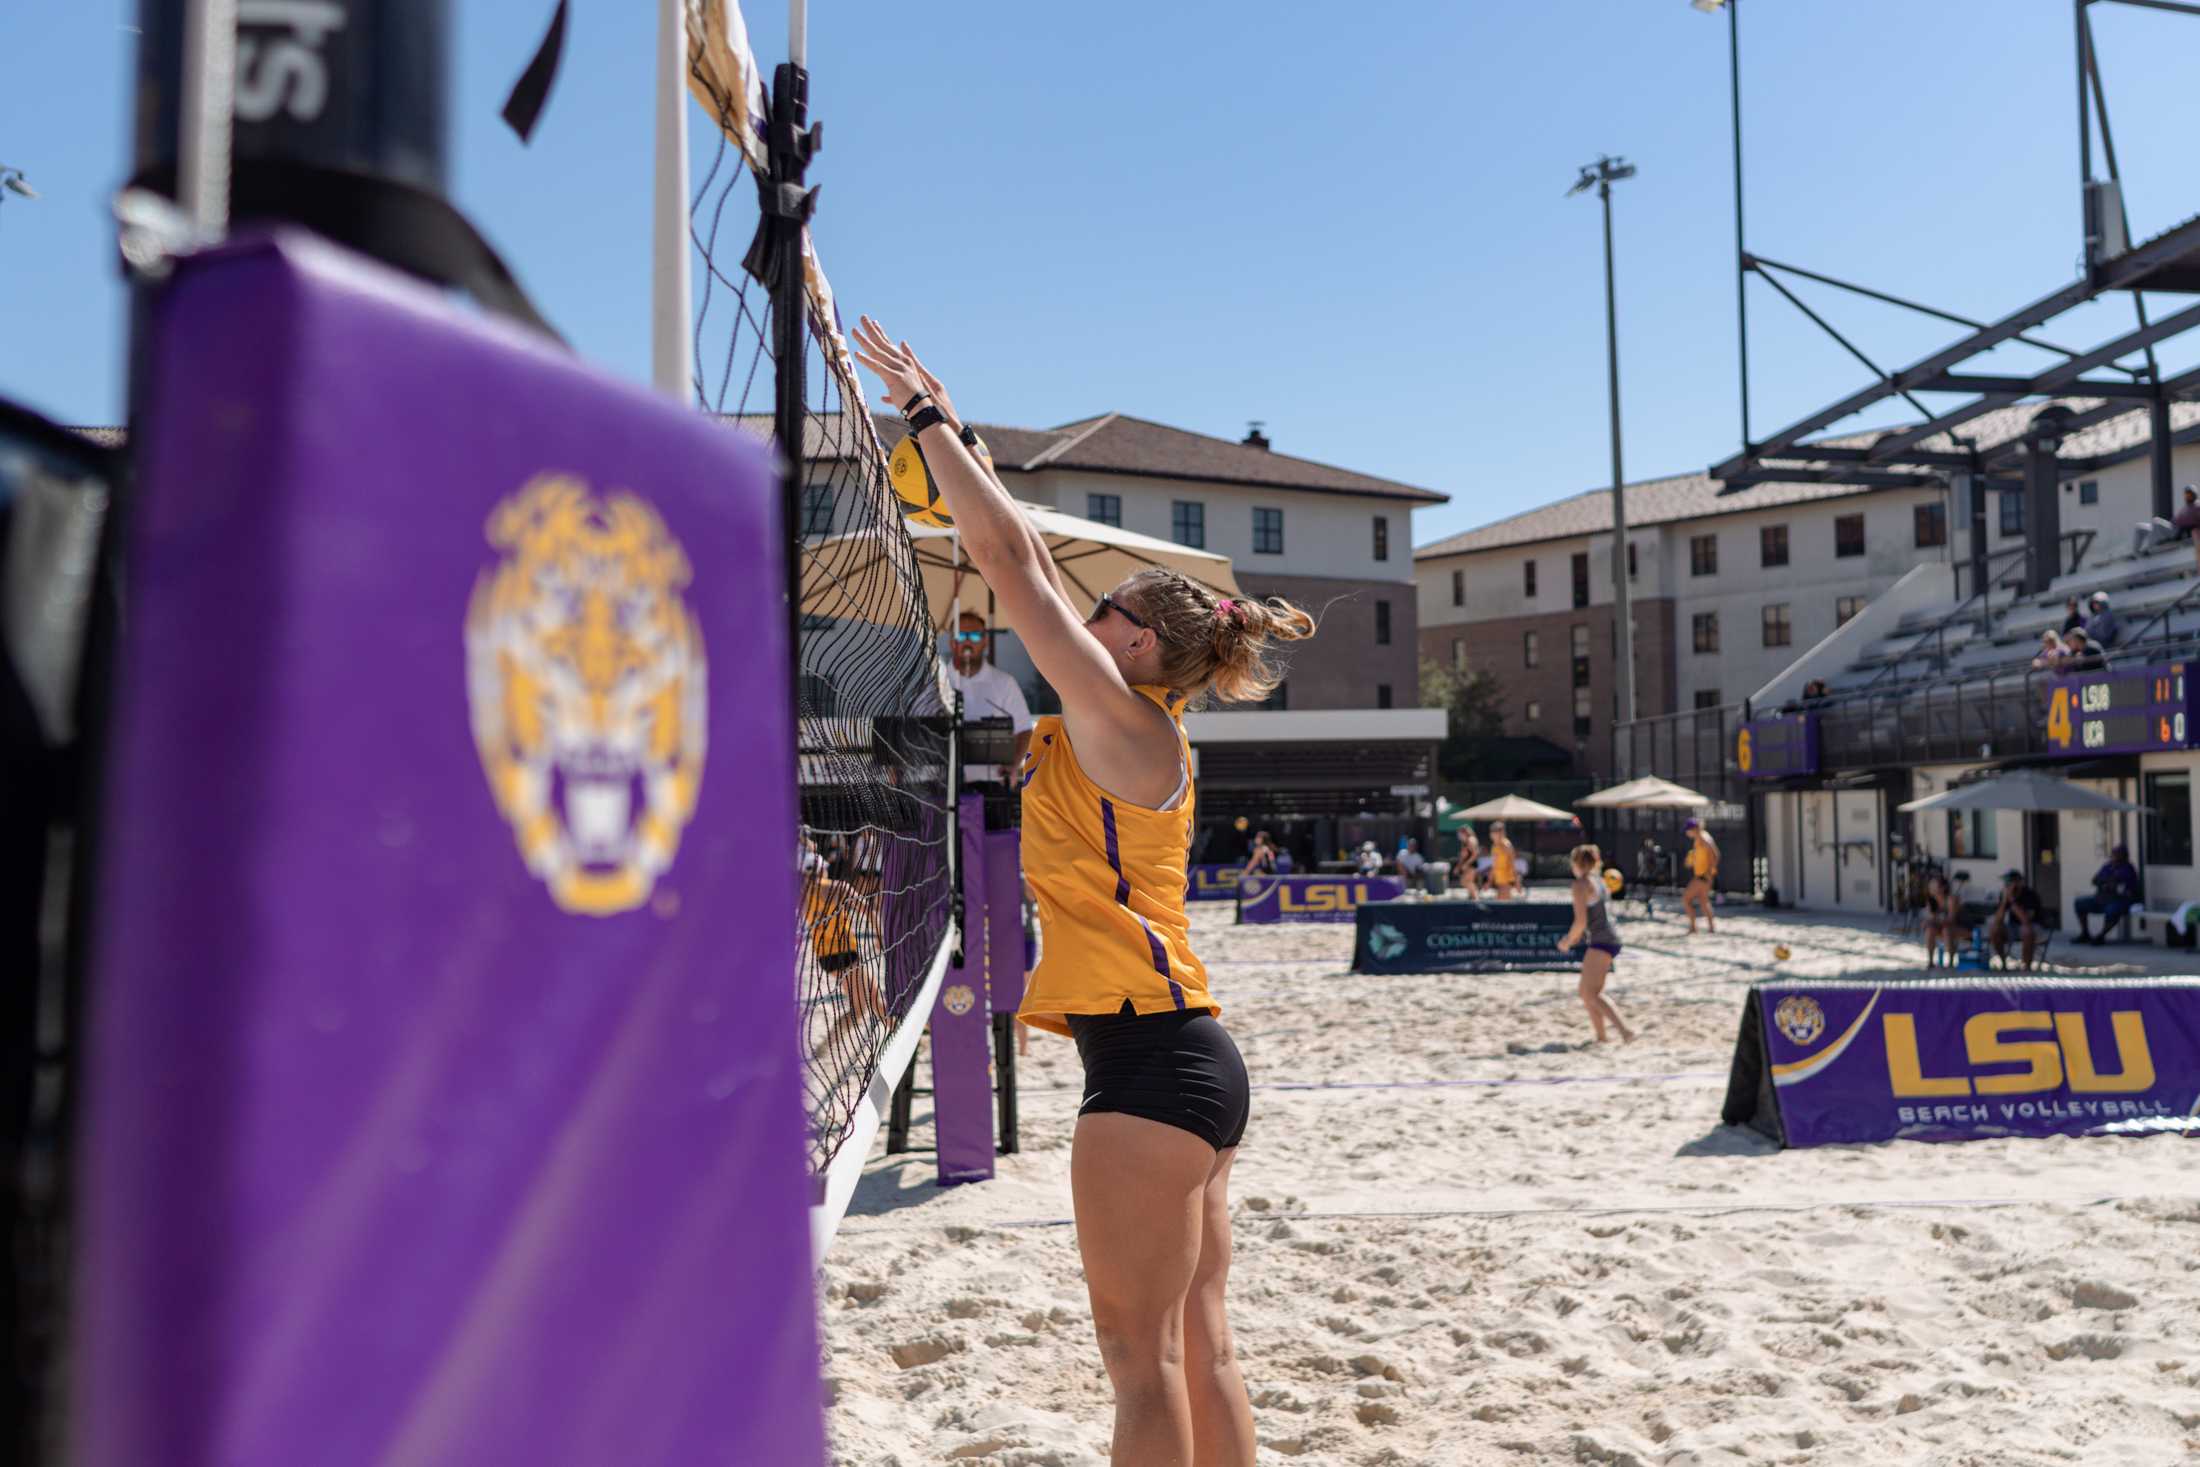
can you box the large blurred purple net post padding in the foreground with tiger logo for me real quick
[70,233,825,1467]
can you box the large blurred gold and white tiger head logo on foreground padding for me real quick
[466,475,706,917]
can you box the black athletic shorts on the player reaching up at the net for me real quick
[1069,999,1252,1150]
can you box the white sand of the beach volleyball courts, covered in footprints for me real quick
[821,906,2200,1467]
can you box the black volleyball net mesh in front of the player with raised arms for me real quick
[691,53,953,1172]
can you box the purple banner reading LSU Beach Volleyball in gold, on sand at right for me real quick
[1725,979,2200,1146]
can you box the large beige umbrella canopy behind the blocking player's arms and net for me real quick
[803,499,1239,631]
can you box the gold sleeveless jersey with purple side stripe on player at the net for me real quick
[1016,684,1223,1034]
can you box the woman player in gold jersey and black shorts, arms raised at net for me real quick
[856,317,1313,1467]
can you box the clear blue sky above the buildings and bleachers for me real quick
[0,0,2200,541]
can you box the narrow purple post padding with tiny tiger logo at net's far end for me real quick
[931,794,998,1188]
